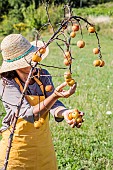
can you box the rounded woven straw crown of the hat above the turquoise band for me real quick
[1,34,31,60]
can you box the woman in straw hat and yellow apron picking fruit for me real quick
[0,34,83,170]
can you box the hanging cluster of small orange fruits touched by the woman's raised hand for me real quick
[64,71,75,86]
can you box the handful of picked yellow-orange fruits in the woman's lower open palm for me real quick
[68,109,83,124]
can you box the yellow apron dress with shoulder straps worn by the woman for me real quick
[0,78,57,170]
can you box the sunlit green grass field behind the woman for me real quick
[1,24,113,170]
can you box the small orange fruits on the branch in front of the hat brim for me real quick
[32,47,46,62]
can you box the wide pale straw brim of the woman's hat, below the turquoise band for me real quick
[0,41,49,73]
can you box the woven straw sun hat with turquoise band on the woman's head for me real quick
[0,34,49,73]
